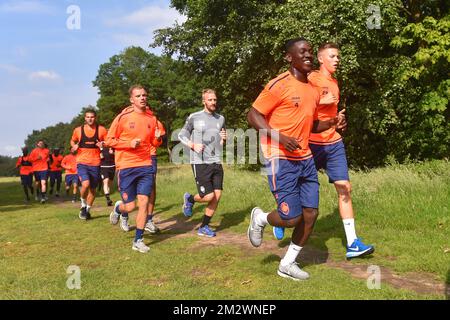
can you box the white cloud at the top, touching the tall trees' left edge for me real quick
[106,6,186,29]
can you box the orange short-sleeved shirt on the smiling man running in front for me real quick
[253,71,320,160]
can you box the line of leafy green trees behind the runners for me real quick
[0,0,450,175]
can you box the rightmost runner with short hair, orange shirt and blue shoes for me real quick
[308,43,375,259]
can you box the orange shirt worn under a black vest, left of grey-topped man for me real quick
[72,124,107,167]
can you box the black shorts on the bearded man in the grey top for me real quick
[192,163,223,197]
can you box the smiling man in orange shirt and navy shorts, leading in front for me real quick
[247,38,344,280]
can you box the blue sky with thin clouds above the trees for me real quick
[0,0,185,156]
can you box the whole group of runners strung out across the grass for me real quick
[14,38,374,280]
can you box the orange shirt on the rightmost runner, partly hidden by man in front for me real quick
[308,71,342,145]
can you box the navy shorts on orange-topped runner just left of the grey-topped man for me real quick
[117,166,154,203]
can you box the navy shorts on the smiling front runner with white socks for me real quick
[266,158,319,220]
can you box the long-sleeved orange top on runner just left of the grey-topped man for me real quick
[106,106,161,170]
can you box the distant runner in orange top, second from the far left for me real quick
[28,140,50,204]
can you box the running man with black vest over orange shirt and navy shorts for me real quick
[70,109,107,220]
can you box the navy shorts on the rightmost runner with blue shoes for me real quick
[309,140,350,183]
